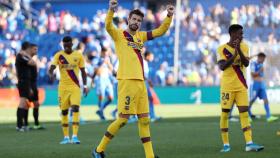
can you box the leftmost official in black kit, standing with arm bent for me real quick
[15,42,36,132]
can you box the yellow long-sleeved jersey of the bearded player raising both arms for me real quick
[106,10,172,80]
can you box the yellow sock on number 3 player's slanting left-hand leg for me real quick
[96,118,128,152]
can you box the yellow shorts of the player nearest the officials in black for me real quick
[58,87,81,110]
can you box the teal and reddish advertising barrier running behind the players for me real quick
[0,87,280,108]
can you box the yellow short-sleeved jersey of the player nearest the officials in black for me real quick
[52,51,85,88]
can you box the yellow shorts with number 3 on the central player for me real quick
[118,80,149,114]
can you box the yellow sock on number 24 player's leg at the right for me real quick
[239,112,252,143]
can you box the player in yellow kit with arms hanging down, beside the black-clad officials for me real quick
[49,36,88,144]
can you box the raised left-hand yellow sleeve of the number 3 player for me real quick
[105,10,118,41]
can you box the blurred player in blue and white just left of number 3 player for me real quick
[94,47,114,120]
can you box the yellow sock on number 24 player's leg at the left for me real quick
[220,112,229,144]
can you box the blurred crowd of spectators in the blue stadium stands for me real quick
[0,0,280,86]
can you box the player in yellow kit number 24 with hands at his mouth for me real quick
[217,24,264,152]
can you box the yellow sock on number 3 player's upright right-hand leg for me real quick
[138,117,155,158]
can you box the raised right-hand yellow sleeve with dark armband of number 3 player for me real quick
[142,16,172,42]
